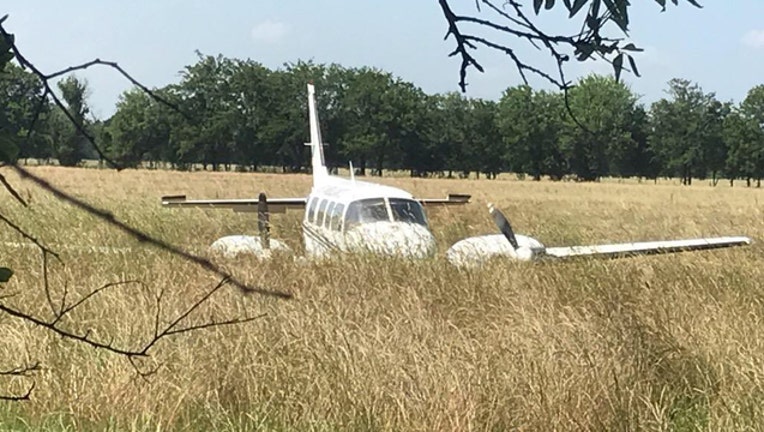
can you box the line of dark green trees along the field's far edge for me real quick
[0,54,764,185]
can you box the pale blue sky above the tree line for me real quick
[0,0,764,118]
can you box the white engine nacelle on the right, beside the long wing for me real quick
[446,234,546,267]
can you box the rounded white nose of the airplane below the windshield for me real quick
[345,222,435,259]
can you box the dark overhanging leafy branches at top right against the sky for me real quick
[438,0,701,91]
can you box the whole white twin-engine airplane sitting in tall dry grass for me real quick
[162,84,751,267]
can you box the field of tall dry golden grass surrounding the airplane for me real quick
[0,167,764,431]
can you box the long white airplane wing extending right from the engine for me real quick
[545,237,751,258]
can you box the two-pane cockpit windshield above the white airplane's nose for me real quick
[345,198,427,230]
